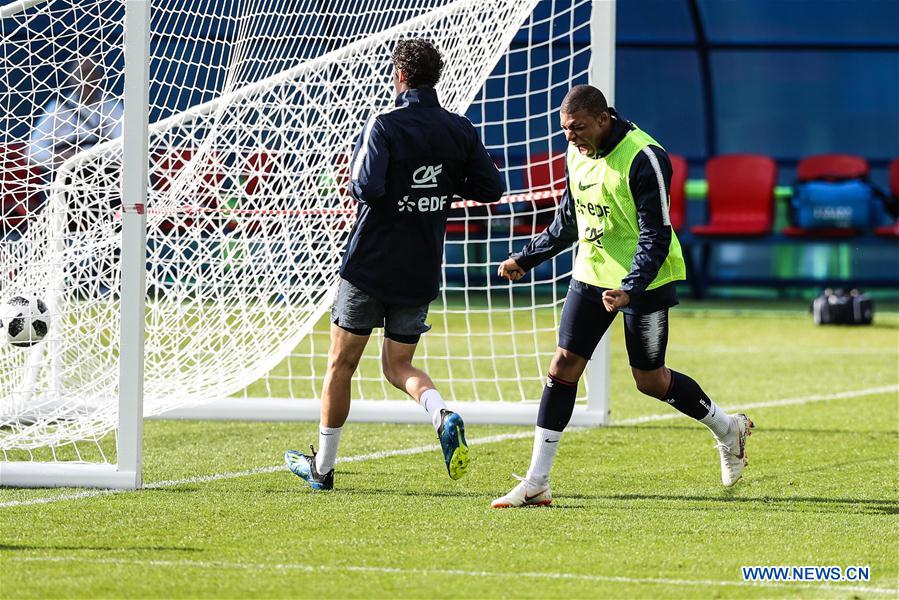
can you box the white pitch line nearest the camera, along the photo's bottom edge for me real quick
[6,556,897,594]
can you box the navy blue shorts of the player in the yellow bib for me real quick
[559,280,677,371]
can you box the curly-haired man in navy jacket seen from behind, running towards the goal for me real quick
[285,39,503,489]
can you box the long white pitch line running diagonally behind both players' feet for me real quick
[0,385,899,508]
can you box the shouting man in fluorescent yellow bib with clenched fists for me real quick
[493,85,753,508]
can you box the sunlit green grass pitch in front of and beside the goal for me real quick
[0,302,899,598]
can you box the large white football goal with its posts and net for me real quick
[0,0,615,488]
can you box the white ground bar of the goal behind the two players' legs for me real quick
[151,398,609,427]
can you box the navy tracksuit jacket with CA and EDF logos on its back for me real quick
[340,88,503,306]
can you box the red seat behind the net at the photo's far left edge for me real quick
[0,144,43,236]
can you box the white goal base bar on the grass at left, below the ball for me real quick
[0,461,140,490]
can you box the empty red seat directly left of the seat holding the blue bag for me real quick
[691,154,777,236]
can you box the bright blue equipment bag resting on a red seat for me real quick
[791,179,875,229]
